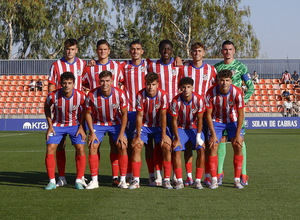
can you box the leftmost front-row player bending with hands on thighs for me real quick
[45,72,86,190]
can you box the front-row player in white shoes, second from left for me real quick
[84,70,128,189]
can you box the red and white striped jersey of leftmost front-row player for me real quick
[46,89,85,127]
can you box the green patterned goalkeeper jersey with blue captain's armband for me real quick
[214,60,254,104]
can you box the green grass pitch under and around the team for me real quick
[0,130,300,219]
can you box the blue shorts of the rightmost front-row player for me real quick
[209,121,244,141]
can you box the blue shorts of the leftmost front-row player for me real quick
[47,125,85,145]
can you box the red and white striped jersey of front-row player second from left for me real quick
[85,87,127,126]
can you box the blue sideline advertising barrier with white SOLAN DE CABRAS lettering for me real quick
[0,117,300,131]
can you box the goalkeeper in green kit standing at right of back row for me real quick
[215,40,254,185]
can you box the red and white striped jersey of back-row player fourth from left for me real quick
[147,58,179,102]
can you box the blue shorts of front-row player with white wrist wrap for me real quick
[174,128,204,152]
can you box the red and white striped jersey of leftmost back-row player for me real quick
[48,57,85,90]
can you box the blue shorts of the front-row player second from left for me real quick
[93,124,127,144]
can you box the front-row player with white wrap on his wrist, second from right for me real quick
[170,77,205,189]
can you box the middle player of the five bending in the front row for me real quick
[129,72,173,189]
